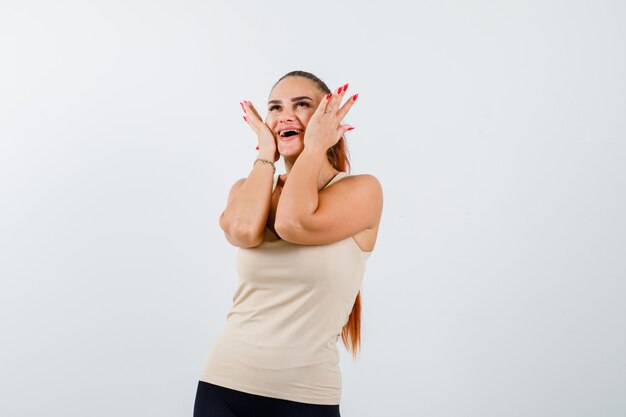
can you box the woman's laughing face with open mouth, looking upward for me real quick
[265,76,325,157]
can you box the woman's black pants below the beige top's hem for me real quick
[193,381,341,417]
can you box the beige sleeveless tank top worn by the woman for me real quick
[200,172,372,404]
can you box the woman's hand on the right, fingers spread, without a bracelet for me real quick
[304,84,358,152]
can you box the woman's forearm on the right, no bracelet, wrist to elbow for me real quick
[276,146,326,225]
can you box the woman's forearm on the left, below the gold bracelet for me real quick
[220,156,274,240]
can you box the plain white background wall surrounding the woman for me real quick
[0,0,626,417]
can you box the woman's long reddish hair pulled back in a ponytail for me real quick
[272,71,361,359]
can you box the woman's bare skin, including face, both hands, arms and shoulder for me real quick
[220,76,383,252]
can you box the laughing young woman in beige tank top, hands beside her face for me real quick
[194,71,383,417]
